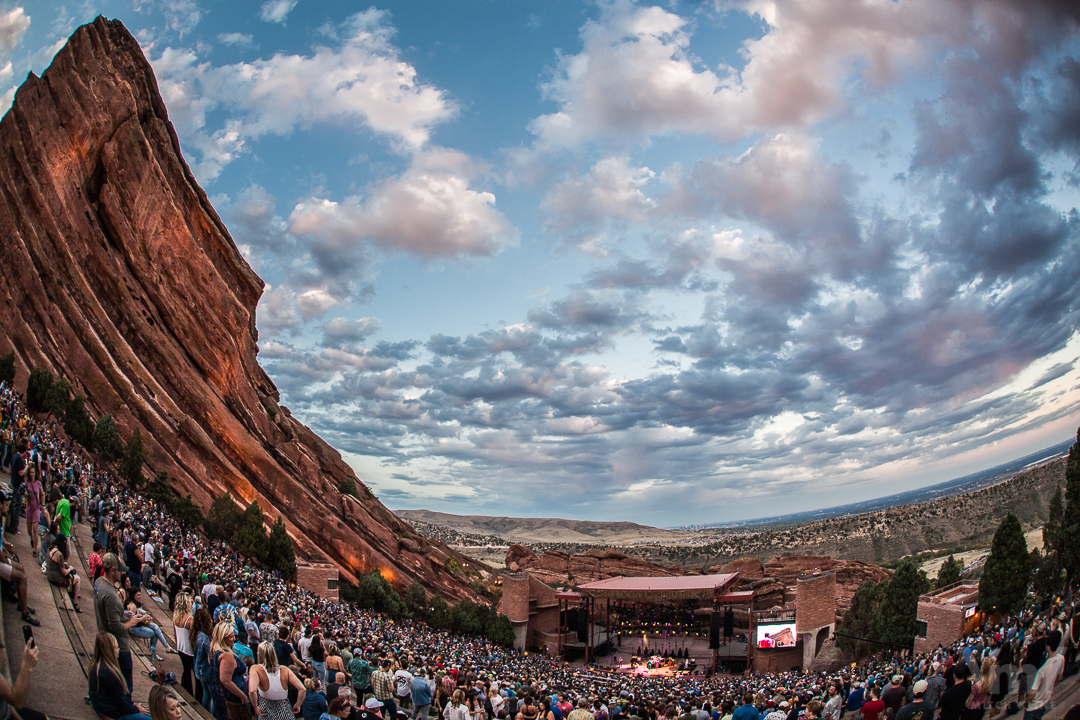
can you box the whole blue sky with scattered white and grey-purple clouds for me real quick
[0,0,1080,526]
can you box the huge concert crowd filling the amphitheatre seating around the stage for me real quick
[0,382,1080,720]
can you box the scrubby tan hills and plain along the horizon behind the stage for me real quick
[397,443,1071,570]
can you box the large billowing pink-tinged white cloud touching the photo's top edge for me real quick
[532,0,946,149]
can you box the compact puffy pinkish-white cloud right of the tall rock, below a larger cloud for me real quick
[288,149,518,257]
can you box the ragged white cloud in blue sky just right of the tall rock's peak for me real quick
[152,9,455,180]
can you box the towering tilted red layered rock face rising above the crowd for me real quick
[0,17,475,599]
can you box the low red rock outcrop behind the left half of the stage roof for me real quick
[505,543,686,586]
